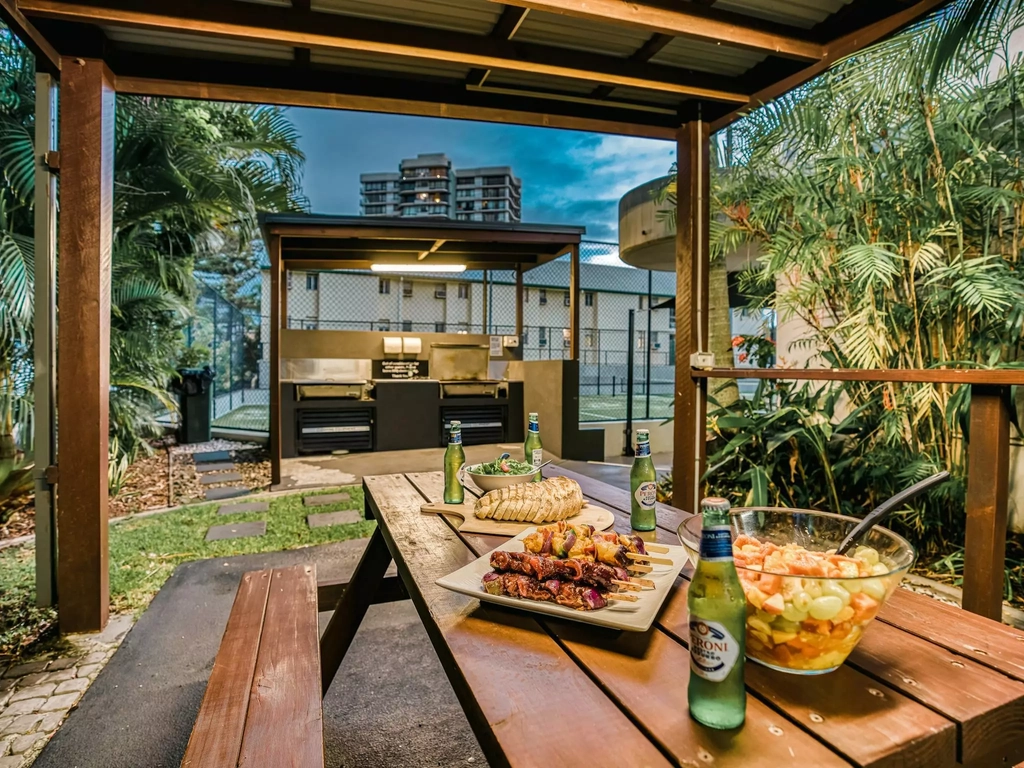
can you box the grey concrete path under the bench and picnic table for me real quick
[35,540,486,768]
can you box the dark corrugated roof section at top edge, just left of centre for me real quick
[311,0,503,35]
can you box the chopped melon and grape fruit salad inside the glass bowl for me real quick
[732,536,899,673]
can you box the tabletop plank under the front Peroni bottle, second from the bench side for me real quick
[409,472,850,768]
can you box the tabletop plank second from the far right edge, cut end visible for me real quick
[847,622,1024,765]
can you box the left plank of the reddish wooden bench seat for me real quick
[181,570,270,768]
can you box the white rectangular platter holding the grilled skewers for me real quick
[437,527,686,632]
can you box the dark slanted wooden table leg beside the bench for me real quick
[321,526,391,695]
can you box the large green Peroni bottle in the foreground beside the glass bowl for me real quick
[686,498,746,728]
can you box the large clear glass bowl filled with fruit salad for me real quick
[679,507,918,675]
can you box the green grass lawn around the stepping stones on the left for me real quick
[0,486,375,658]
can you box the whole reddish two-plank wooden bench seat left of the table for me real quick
[181,565,324,768]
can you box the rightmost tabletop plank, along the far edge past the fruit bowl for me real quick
[879,590,1024,681]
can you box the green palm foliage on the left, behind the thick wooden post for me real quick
[0,28,306,481]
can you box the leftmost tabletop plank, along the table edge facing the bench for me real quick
[364,475,670,768]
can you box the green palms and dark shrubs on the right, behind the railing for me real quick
[708,0,1024,588]
